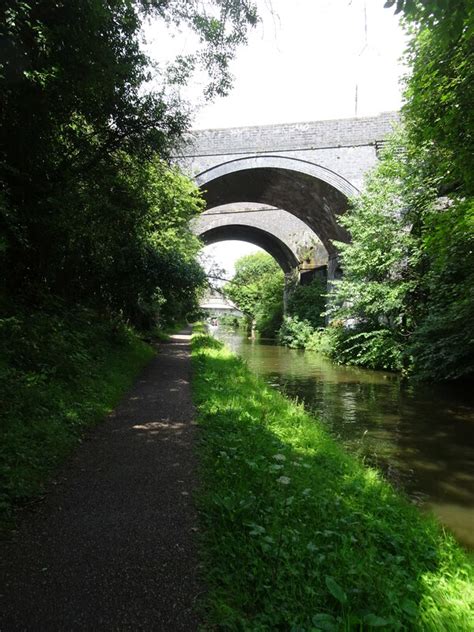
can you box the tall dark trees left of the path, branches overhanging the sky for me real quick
[0,0,256,320]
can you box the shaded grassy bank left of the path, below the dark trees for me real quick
[0,302,153,526]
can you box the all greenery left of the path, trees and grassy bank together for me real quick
[0,0,256,520]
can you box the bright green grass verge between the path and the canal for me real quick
[193,334,474,632]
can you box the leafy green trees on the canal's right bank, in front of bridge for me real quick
[326,0,474,380]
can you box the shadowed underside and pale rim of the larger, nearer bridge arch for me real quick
[196,156,358,255]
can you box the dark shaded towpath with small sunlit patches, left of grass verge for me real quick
[0,331,202,632]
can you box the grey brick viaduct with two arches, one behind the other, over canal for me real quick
[176,112,398,279]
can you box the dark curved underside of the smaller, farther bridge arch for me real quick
[199,224,299,272]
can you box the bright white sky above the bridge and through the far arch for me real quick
[145,0,406,274]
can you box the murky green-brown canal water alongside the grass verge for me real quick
[213,328,474,550]
